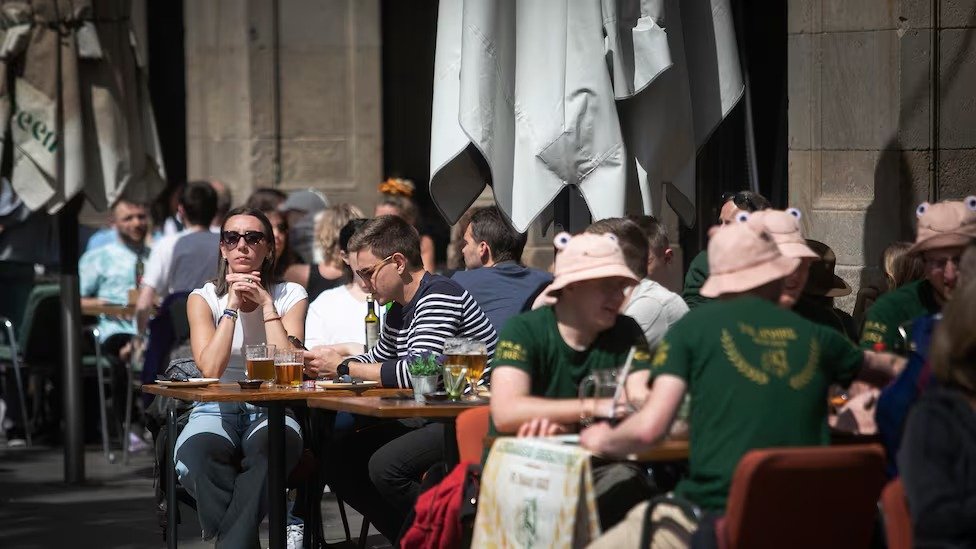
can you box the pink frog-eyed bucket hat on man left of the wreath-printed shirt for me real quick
[532,232,640,309]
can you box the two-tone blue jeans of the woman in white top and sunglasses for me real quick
[175,402,302,548]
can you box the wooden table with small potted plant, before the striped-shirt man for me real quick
[308,395,488,472]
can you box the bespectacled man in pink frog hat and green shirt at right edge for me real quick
[861,196,976,351]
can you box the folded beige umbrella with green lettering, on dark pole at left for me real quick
[0,0,164,482]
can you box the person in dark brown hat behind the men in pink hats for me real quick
[793,239,857,341]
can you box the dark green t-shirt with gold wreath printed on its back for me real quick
[652,297,863,510]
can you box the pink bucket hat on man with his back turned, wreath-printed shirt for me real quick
[701,223,800,297]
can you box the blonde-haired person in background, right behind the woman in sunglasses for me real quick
[285,203,365,301]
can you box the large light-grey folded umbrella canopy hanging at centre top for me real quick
[430,0,743,231]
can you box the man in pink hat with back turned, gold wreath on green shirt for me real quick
[581,223,896,547]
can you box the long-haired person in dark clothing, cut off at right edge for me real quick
[898,272,976,547]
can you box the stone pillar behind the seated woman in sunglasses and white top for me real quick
[184,0,382,211]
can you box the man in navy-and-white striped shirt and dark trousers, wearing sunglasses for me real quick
[305,215,497,543]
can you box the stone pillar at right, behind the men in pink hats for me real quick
[788,0,976,310]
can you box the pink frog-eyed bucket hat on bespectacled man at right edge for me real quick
[908,196,976,253]
